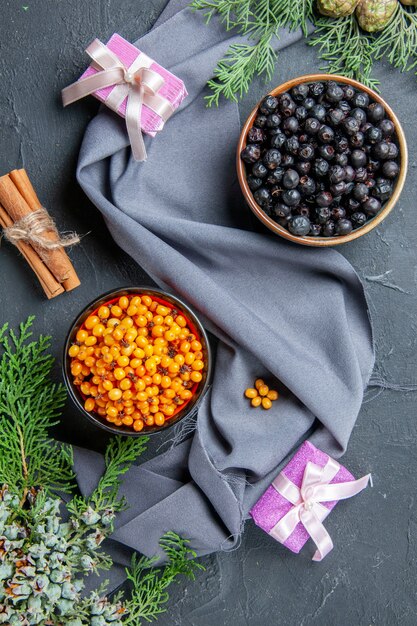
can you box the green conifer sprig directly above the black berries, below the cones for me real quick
[309,14,379,89]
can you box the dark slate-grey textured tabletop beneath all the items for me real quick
[0,0,417,626]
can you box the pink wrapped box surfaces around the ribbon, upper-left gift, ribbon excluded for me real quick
[81,33,188,137]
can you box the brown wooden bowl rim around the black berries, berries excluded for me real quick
[236,74,408,247]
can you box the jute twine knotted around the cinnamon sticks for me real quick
[3,207,80,251]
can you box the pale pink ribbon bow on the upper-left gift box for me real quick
[62,39,174,161]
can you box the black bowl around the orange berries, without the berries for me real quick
[62,285,213,437]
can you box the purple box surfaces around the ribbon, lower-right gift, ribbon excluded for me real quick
[250,441,354,554]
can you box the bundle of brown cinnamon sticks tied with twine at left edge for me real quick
[0,169,80,298]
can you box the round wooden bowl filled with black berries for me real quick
[237,74,408,247]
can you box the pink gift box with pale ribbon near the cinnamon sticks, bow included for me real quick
[62,33,188,161]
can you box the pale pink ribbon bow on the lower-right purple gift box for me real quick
[269,458,371,561]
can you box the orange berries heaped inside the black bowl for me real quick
[68,295,205,432]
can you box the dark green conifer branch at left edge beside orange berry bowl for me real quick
[0,317,73,500]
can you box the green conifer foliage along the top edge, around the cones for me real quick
[191,0,417,106]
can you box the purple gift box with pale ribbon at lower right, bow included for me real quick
[250,441,371,561]
